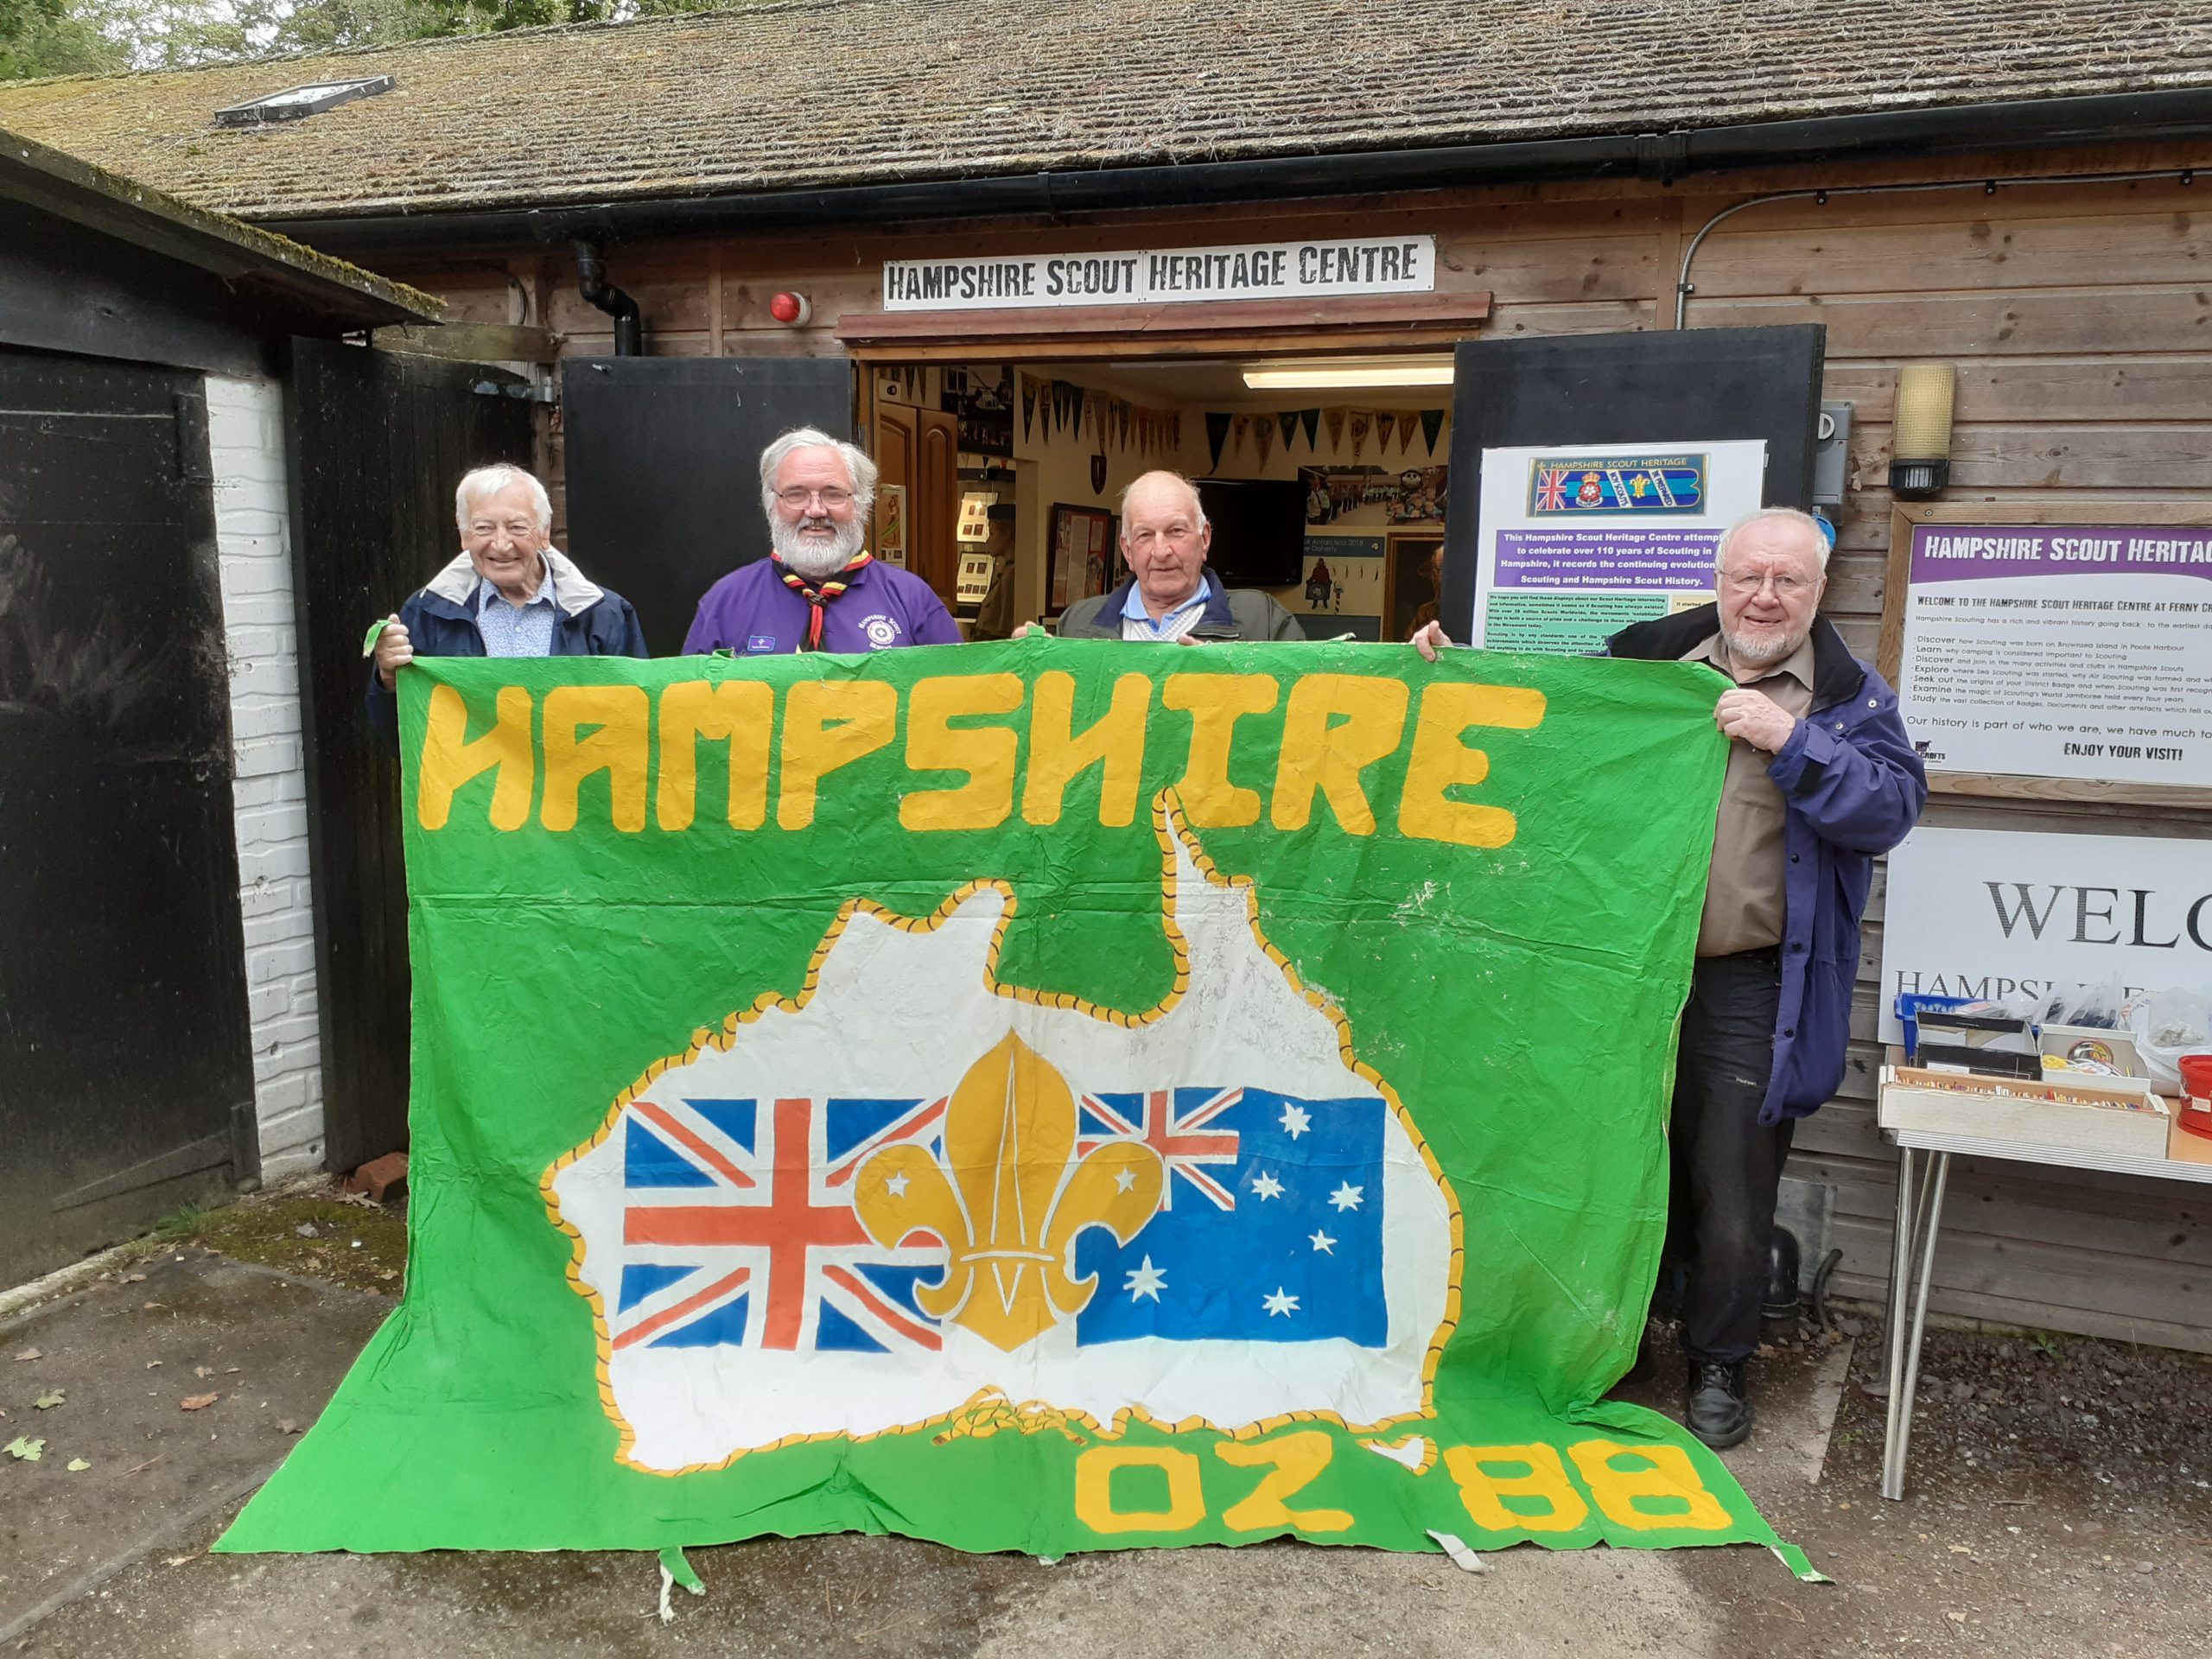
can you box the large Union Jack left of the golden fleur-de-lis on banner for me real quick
[608,1097,944,1354]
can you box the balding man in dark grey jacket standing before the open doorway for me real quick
[1059,471,1305,644]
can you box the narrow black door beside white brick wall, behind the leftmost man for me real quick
[288,340,531,1170]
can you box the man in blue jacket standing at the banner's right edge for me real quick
[1414,506,1927,1446]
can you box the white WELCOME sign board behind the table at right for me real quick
[1880,825,2212,1042]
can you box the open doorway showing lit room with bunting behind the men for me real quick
[861,358,1451,639]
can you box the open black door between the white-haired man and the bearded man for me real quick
[562,356,852,657]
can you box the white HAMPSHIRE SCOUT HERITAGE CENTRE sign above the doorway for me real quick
[882,237,1435,312]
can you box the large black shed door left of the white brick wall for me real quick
[0,349,254,1285]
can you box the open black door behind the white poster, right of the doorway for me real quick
[1440,323,1827,635]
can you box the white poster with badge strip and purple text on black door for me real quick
[1471,440,1767,655]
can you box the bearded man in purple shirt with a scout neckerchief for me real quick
[683,427,960,657]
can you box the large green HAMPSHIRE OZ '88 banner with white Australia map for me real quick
[221,639,1801,1564]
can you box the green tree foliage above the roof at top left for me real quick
[0,0,743,79]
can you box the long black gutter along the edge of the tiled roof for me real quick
[257,86,2212,259]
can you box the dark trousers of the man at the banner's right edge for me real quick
[1666,951,1794,1365]
